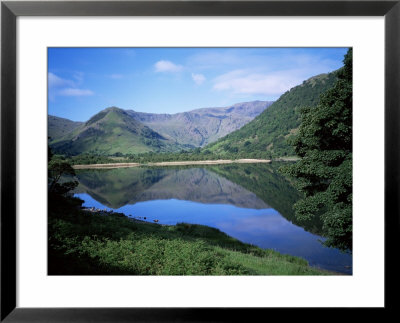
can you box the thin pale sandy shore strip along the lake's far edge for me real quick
[72,159,271,169]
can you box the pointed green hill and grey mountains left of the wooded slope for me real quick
[48,101,273,155]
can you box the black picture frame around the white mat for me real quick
[0,0,400,322]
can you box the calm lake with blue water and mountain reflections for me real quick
[75,164,352,275]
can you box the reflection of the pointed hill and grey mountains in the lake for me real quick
[76,168,269,209]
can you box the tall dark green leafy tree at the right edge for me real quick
[283,49,353,251]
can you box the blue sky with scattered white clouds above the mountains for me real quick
[48,48,347,121]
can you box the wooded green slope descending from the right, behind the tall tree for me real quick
[203,71,337,158]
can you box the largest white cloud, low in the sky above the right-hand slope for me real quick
[213,70,304,95]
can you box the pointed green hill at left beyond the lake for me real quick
[50,107,182,155]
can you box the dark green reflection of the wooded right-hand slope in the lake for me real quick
[208,163,322,235]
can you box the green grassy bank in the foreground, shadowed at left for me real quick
[49,195,329,275]
